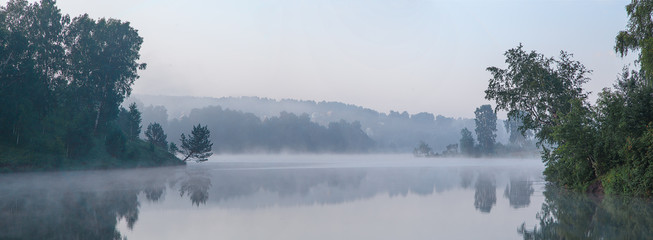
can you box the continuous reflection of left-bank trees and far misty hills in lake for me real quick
[0,160,552,239]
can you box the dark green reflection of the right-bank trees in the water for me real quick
[518,186,653,239]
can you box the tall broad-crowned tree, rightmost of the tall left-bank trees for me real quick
[64,14,146,137]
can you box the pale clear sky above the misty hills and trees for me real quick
[35,0,632,117]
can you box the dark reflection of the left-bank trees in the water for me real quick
[0,169,181,239]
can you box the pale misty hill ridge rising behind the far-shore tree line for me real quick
[125,94,508,152]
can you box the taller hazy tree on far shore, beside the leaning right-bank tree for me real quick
[474,105,497,154]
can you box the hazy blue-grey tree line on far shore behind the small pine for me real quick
[166,106,375,153]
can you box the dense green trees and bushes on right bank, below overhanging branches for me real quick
[486,43,653,196]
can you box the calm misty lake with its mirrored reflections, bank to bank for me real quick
[0,155,653,239]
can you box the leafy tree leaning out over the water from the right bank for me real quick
[485,44,591,144]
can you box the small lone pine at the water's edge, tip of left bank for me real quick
[181,124,213,162]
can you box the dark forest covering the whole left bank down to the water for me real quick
[0,0,181,170]
